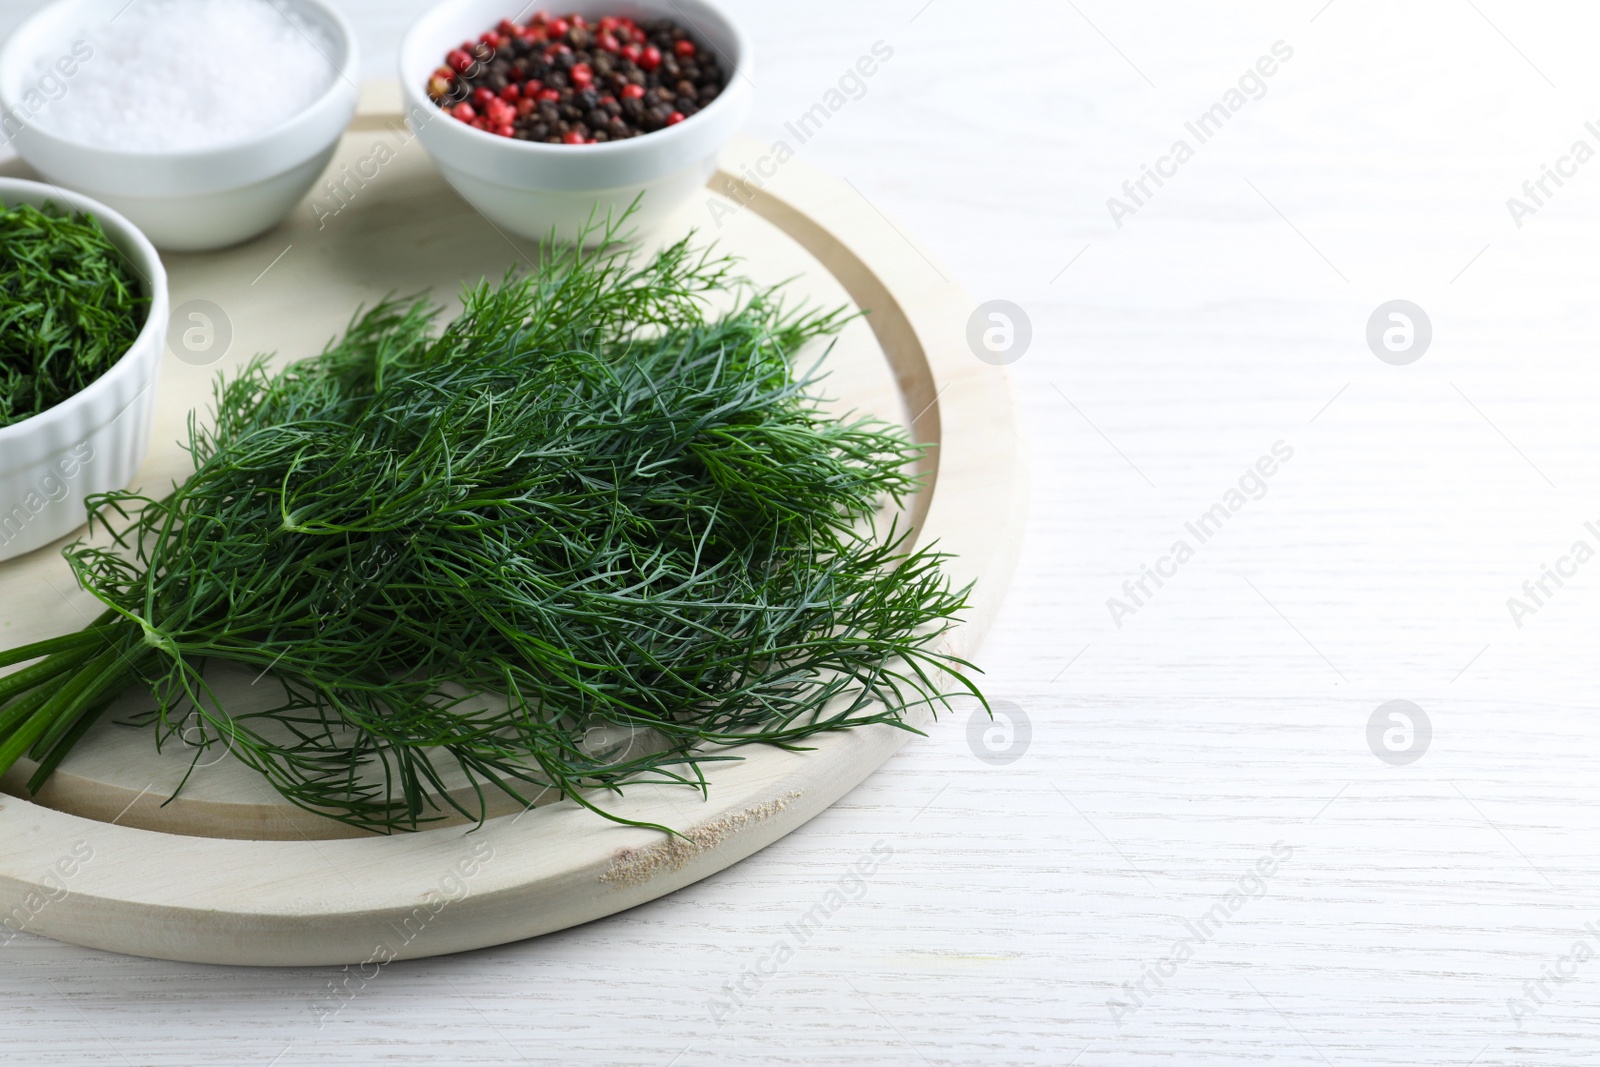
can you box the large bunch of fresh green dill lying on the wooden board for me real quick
[0,231,976,830]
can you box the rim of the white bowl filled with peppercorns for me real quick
[395,0,752,158]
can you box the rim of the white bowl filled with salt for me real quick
[0,0,360,165]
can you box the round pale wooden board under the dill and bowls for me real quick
[0,95,1024,965]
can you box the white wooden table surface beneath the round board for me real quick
[9,0,1600,1067]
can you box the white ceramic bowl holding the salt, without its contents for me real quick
[0,0,358,251]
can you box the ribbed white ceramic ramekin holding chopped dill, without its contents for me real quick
[0,178,166,560]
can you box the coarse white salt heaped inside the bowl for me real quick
[35,0,341,152]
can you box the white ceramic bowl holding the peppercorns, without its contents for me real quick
[400,0,752,240]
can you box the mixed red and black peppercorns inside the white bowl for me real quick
[427,11,725,144]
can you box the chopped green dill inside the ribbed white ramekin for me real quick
[0,203,150,426]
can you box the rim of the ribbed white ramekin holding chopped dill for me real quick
[0,176,168,446]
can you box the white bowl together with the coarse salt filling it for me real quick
[0,0,358,251]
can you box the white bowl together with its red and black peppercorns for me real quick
[400,0,750,240]
